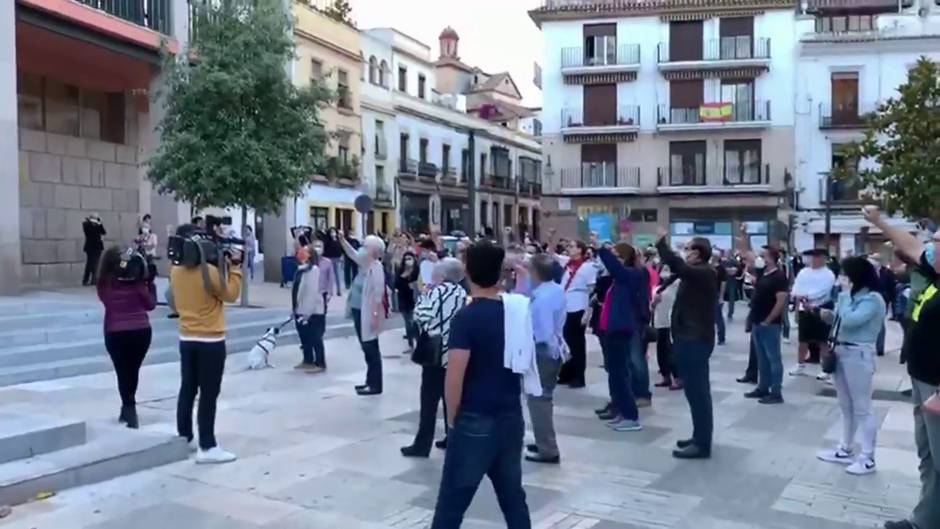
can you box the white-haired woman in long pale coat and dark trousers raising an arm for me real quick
[339,235,388,396]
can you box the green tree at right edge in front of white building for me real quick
[833,57,940,219]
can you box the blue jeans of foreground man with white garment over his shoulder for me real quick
[431,408,532,529]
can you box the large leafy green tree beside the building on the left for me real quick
[147,0,331,304]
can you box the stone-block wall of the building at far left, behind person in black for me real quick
[19,129,141,286]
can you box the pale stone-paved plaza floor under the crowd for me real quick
[0,309,919,529]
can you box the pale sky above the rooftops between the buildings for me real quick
[350,0,542,106]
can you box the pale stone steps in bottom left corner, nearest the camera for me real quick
[0,423,189,505]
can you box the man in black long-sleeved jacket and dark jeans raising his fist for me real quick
[656,228,718,459]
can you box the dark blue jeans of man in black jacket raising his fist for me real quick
[673,336,715,452]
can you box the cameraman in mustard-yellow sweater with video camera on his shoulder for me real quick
[168,221,244,464]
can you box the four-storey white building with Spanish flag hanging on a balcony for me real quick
[530,0,796,249]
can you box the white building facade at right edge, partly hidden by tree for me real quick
[794,0,940,255]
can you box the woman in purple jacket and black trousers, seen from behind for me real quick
[98,246,157,429]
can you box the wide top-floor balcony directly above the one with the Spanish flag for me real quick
[656,36,770,71]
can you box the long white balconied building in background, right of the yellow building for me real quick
[363,28,541,236]
